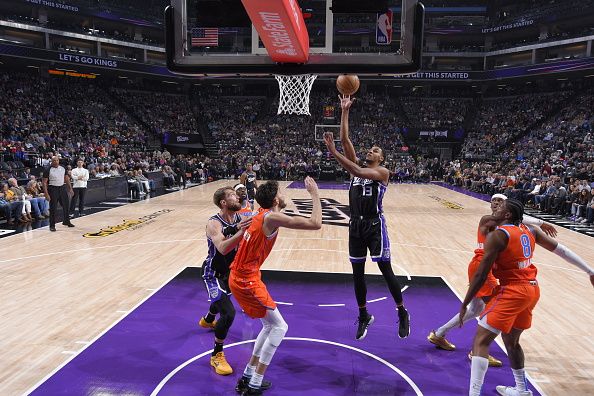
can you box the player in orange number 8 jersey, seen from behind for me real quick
[459,199,594,396]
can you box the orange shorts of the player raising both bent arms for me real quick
[229,271,276,318]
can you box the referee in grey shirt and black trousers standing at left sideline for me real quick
[43,156,74,231]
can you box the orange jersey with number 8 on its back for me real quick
[493,224,537,285]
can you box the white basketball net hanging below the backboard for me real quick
[274,74,318,115]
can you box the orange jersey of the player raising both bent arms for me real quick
[231,208,278,277]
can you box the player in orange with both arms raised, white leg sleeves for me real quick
[229,177,322,395]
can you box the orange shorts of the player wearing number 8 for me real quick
[480,283,540,333]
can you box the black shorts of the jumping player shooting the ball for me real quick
[349,215,390,263]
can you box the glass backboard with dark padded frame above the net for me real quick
[165,0,424,77]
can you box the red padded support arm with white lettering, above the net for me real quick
[241,0,309,63]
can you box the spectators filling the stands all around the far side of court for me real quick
[0,68,594,230]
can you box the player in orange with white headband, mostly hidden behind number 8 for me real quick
[427,194,557,367]
